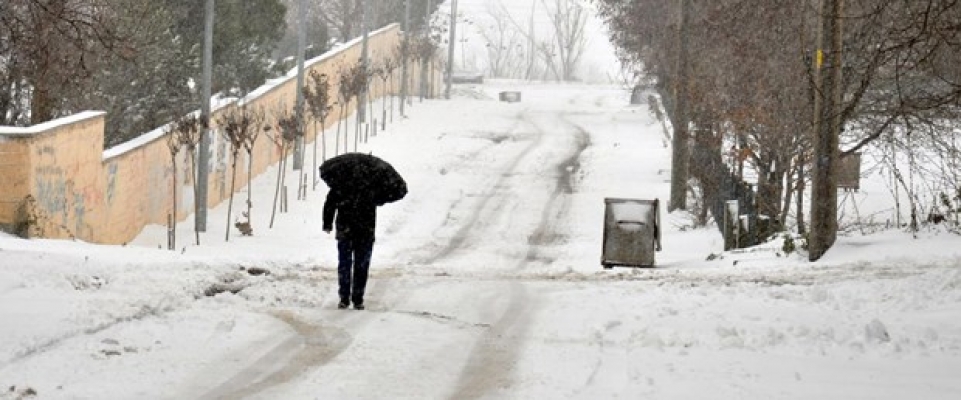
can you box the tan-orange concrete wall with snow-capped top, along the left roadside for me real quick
[0,25,441,244]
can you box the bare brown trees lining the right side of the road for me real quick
[595,0,961,244]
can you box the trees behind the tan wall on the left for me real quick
[0,0,438,147]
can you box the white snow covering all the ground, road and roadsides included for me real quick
[0,82,961,399]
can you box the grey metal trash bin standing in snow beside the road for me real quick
[601,198,661,269]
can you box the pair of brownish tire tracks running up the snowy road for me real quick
[217,102,589,398]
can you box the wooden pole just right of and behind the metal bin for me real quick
[667,0,691,211]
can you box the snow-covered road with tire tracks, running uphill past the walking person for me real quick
[211,86,624,398]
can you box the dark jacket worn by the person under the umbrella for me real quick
[324,190,377,241]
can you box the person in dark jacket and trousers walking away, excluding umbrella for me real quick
[323,189,377,310]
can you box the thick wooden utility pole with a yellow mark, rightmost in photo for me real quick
[808,0,843,261]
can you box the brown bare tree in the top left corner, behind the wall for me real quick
[0,0,129,124]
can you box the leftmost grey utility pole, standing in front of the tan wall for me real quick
[194,0,214,232]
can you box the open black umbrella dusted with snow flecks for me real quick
[320,153,407,205]
